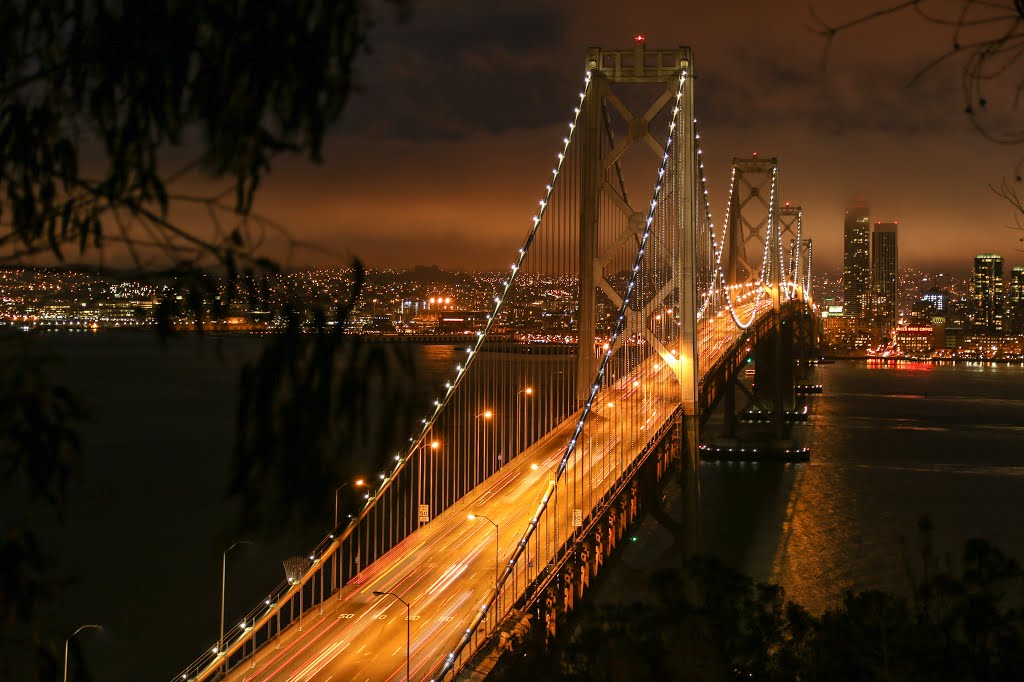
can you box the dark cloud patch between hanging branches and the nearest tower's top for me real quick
[343,0,570,139]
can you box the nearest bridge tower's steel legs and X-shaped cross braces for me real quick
[577,38,700,547]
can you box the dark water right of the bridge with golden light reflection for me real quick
[701,363,1024,611]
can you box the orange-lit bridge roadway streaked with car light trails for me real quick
[216,303,765,682]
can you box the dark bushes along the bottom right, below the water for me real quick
[503,529,1024,682]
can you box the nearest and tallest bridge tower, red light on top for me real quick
[577,36,699,545]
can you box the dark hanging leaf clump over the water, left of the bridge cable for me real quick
[230,262,415,531]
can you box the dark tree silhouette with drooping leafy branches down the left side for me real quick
[0,0,409,680]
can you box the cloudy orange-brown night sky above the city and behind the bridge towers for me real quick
[247,0,1024,271]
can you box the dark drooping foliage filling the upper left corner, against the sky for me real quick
[0,0,404,270]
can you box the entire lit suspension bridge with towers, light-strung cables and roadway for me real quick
[174,38,813,682]
